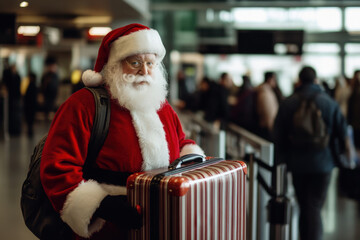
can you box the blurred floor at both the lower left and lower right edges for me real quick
[0,121,360,240]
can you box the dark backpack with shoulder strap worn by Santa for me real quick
[21,88,110,240]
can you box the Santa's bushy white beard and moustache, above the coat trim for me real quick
[103,63,167,112]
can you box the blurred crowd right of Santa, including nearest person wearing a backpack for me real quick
[179,66,360,240]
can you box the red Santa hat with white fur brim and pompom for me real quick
[82,23,166,87]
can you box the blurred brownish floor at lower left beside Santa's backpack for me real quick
[0,122,49,240]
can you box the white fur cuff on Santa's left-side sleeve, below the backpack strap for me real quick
[60,180,126,238]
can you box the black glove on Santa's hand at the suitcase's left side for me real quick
[94,196,142,229]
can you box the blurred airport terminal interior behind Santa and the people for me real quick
[0,0,360,240]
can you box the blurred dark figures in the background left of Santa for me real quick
[0,56,83,137]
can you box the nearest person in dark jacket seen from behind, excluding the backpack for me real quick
[274,66,347,240]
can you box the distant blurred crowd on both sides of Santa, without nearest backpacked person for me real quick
[1,56,360,148]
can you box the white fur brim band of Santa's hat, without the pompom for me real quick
[108,29,166,63]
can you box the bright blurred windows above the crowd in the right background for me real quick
[152,1,360,98]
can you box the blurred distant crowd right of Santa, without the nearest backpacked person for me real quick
[177,67,360,148]
